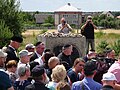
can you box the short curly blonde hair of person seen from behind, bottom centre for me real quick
[51,65,66,82]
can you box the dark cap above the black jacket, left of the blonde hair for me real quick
[32,65,45,77]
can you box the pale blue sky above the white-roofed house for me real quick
[19,0,120,12]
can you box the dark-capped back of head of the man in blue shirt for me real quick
[84,60,97,76]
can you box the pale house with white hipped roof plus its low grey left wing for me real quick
[35,3,84,27]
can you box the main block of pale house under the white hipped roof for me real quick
[54,3,82,26]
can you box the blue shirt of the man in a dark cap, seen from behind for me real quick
[71,77,102,90]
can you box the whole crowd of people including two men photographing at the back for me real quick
[0,16,120,90]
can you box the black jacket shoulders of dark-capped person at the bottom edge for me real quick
[25,82,49,90]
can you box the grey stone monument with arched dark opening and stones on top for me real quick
[37,33,85,61]
